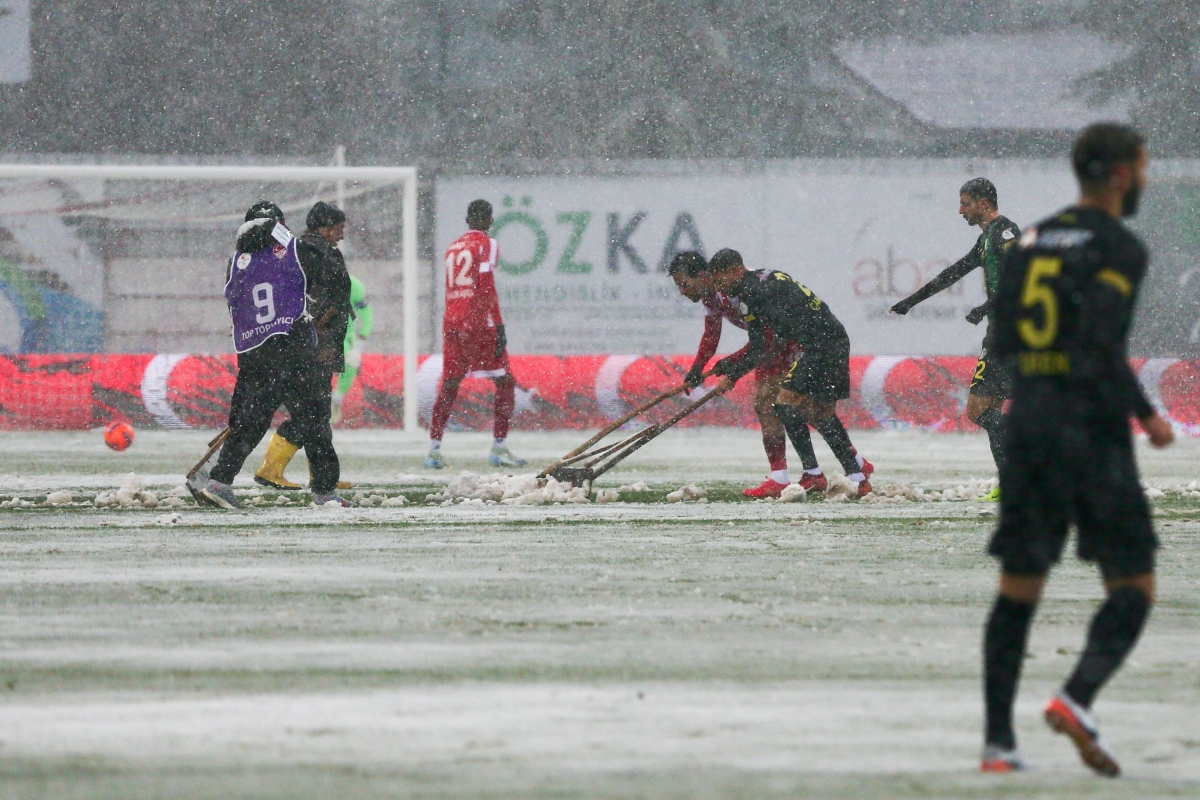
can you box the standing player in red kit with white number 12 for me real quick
[425,200,526,469]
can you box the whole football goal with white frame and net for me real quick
[0,164,422,431]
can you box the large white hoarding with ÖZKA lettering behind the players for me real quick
[436,160,1074,355]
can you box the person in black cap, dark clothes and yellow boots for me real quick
[254,200,354,491]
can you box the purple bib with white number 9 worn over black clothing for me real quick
[226,224,307,353]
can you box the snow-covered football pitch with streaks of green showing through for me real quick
[0,429,1200,799]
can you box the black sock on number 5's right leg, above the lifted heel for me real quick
[1063,587,1150,709]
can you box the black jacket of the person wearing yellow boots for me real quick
[296,230,354,372]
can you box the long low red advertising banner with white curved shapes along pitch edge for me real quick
[0,354,1200,435]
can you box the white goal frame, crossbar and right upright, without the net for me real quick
[0,163,419,434]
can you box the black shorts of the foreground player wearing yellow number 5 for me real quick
[988,387,1158,581]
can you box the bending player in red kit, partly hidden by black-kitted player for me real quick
[667,251,811,498]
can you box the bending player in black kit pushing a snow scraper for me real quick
[700,248,875,498]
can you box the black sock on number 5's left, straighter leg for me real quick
[983,595,1036,750]
